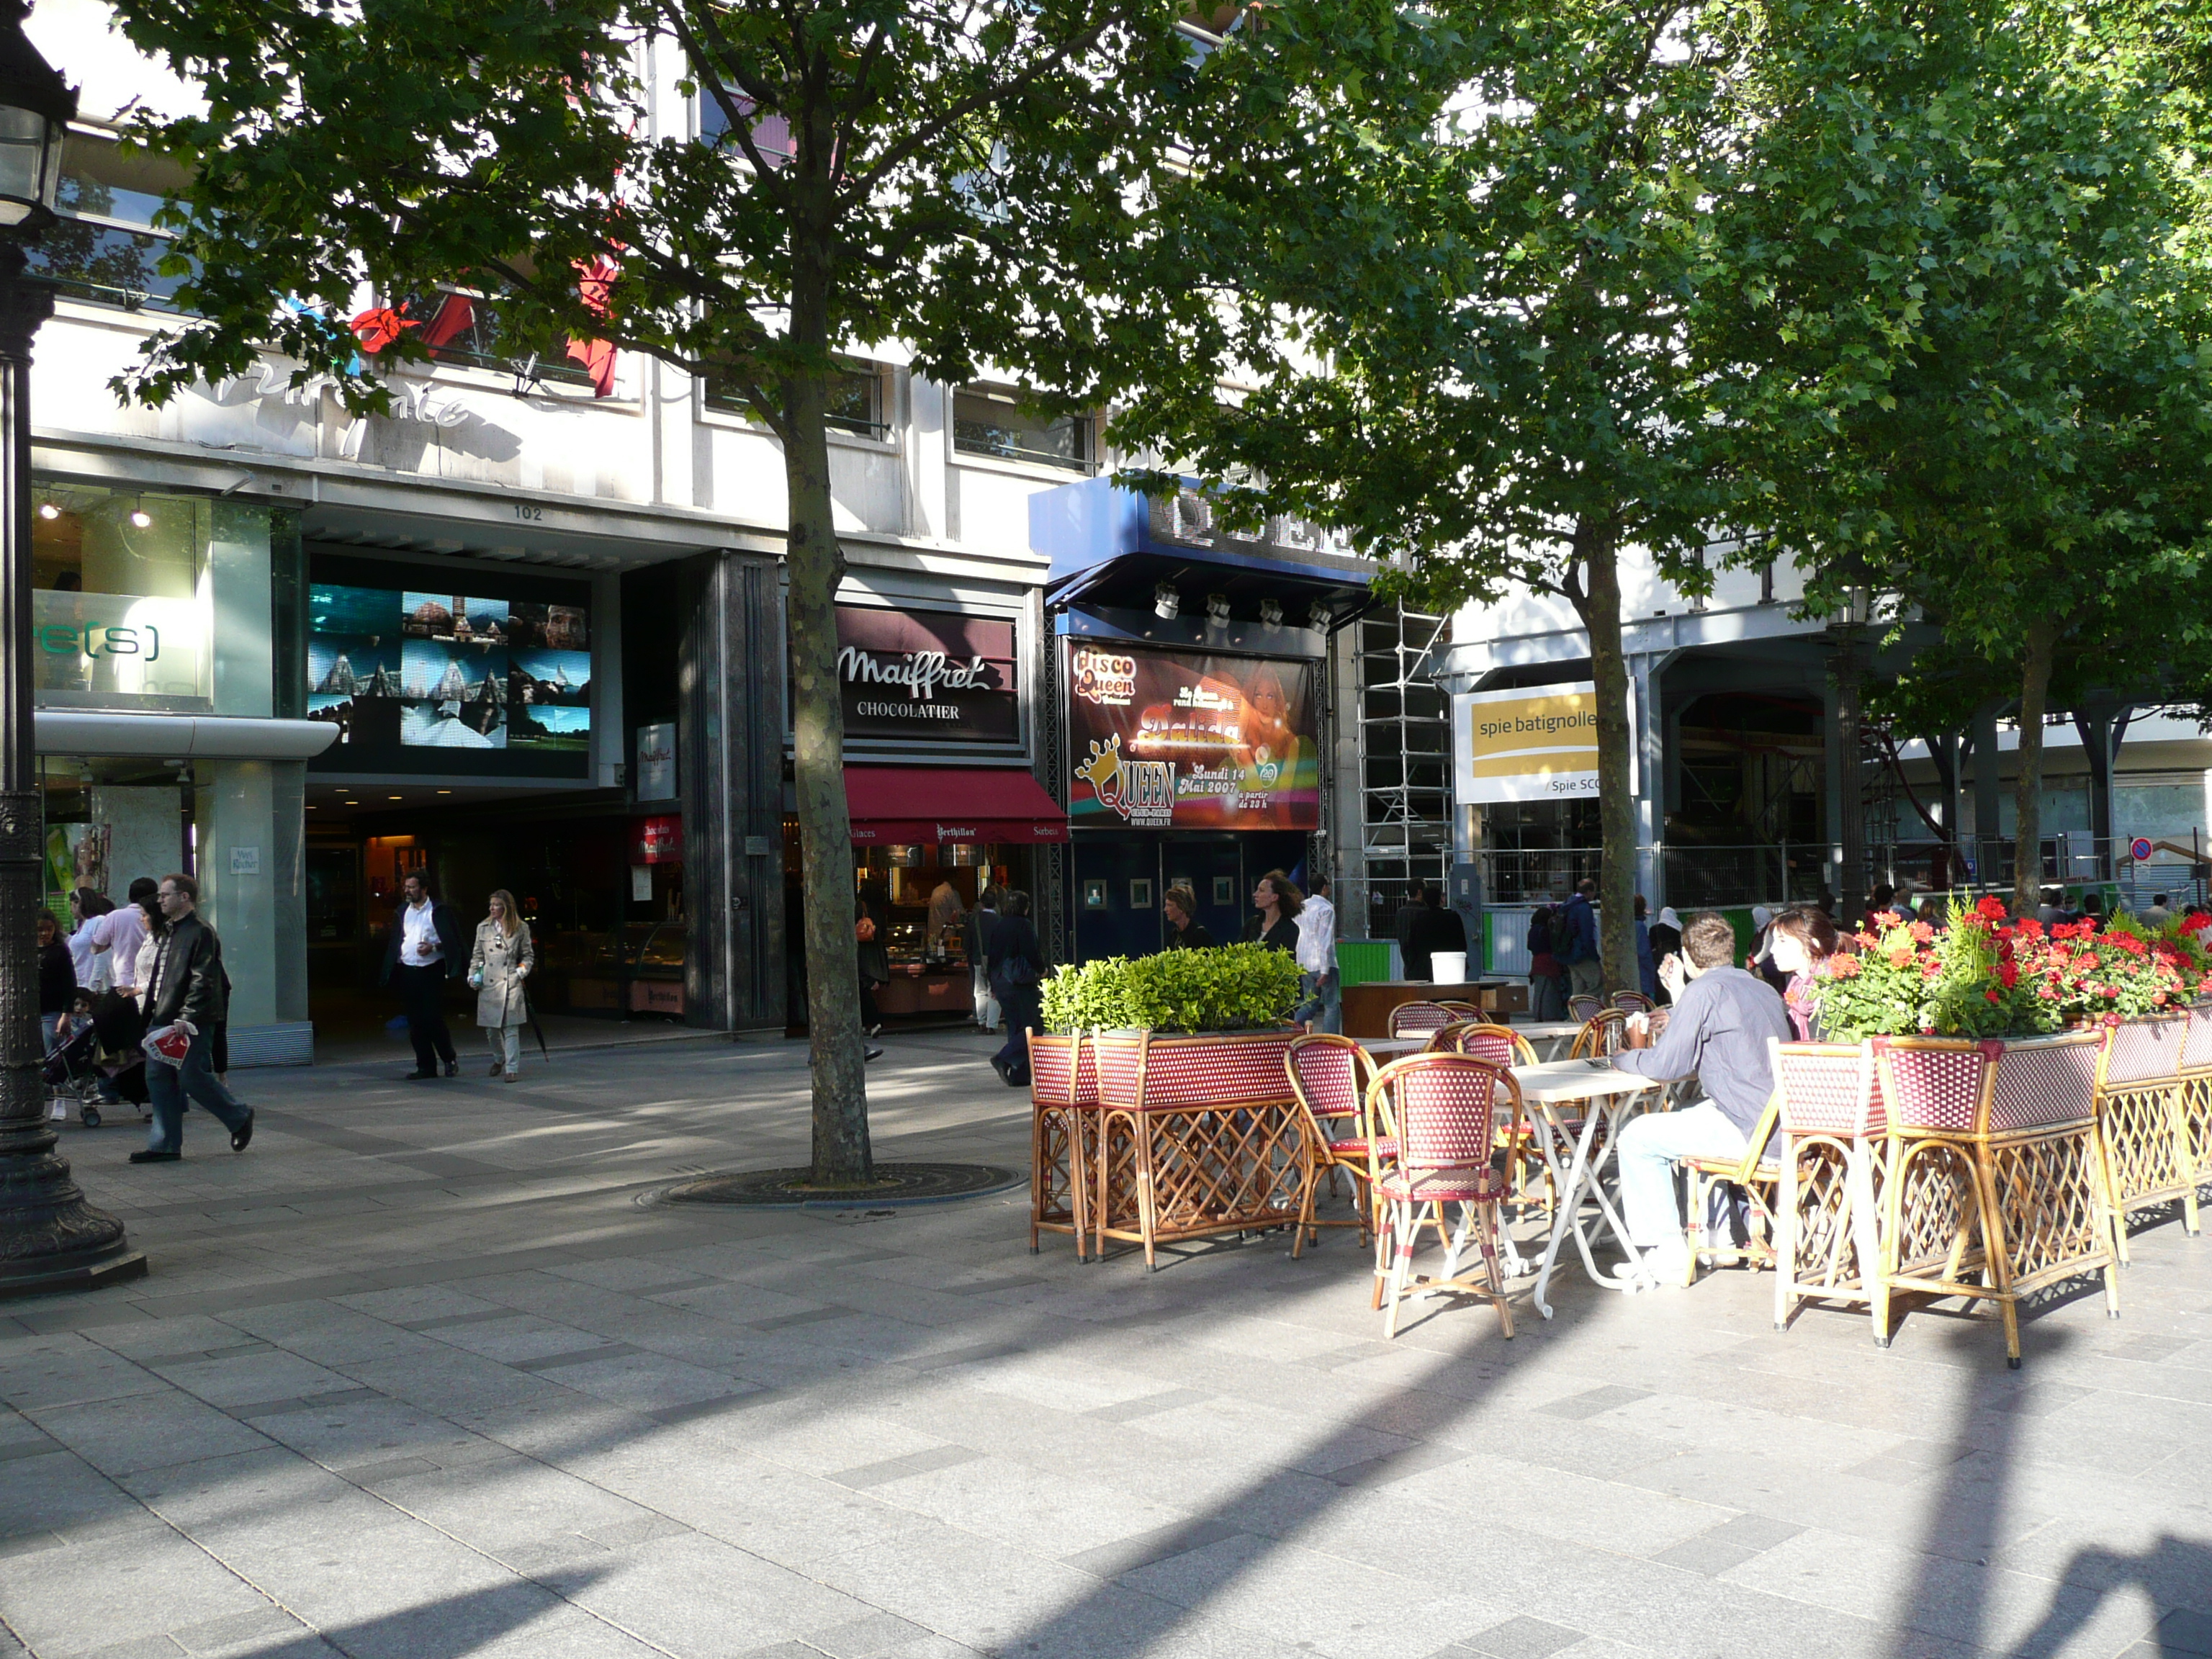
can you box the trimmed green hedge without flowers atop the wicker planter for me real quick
[1044,945,1298,1033]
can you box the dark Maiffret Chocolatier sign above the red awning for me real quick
[836,604,1022,743]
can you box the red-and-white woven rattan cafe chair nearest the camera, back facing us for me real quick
[1367,1055,1522,1341]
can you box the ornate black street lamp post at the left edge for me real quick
[0,0,146,1296]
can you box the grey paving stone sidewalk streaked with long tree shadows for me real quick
[0,1035,2212,1659]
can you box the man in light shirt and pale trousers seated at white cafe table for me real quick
[1612,909,1794,1285]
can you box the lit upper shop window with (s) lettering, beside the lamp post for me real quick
[31,480,215,712]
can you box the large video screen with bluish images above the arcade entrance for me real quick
[307,562,590,774]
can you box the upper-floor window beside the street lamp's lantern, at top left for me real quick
[29,130,197,312]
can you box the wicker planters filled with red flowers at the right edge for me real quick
[1809,898,2212,1362]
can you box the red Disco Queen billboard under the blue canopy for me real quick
[1069,639,1321,830]
